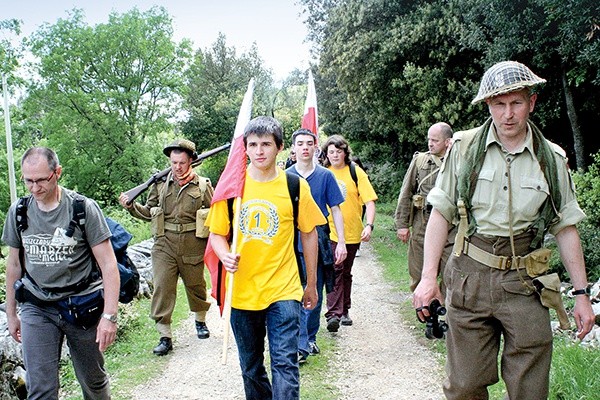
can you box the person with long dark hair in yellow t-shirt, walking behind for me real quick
[322,135,377,332]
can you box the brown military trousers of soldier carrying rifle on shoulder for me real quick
[150,231,210,325]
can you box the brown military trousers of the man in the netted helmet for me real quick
[444,235,552,400]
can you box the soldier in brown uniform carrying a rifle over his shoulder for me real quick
[119,139,213,355]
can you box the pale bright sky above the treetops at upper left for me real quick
[0,0,309,79]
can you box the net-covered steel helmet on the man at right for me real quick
[471,61,546,104]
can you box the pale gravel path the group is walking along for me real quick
[133,245,443,400]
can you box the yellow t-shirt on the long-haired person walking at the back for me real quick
[328,165,377,244]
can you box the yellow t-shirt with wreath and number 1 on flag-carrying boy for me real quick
[206,171,326,310]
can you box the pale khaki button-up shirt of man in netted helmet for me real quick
[427,124,585,236]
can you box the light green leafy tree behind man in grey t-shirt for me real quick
[28,7,191,204]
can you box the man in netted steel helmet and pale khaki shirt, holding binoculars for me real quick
[413,61,594,400]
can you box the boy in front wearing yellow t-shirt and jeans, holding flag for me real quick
[206,117,326,399]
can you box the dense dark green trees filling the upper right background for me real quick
[301,0,600,200]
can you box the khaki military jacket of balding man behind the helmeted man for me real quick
[394,151,442,229]
